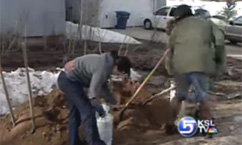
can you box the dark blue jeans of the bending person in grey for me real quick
[58,72,105,145]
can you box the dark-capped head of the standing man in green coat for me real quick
[174,5,193,21]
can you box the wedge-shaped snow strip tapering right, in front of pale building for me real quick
[66,22,141,44]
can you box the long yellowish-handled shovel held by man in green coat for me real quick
[119,49,170,122]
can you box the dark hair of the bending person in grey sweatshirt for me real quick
[115,56,131,76]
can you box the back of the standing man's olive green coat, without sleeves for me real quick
[170,17,215,74]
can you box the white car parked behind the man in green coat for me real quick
[144,6,210,29]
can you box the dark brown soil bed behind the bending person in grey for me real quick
[2,42,166,73]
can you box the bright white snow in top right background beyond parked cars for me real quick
[167,0,242,16]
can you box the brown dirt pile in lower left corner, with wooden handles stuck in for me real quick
[0,91,68,145]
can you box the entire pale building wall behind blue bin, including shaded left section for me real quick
[66,0,166,28]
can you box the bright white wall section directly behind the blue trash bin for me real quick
[100,0,166,28]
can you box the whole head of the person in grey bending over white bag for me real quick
[111,51,131,76]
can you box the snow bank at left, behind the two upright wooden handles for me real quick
[0,68,58,116]
